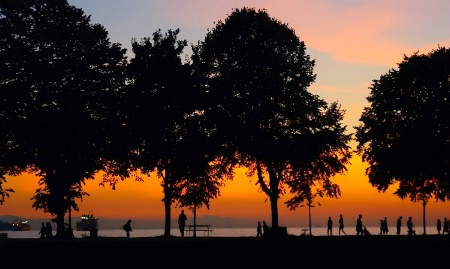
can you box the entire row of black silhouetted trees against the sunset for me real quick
[0,0,450,236]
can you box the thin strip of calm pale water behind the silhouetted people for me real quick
[0,226,437,238]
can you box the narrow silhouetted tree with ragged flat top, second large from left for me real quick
[121,29,199,236]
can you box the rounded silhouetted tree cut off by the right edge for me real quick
[355,47,450,233]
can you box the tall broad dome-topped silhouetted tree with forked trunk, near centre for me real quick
[192,7,351,229]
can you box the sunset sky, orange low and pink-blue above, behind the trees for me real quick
[0,0,450,227]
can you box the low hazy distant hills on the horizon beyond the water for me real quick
[0,214,257,230]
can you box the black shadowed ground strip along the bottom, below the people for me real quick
[0,235,450,268]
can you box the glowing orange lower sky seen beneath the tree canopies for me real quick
[0,153,450,227]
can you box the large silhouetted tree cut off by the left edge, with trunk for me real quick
[0,0,126,235]
